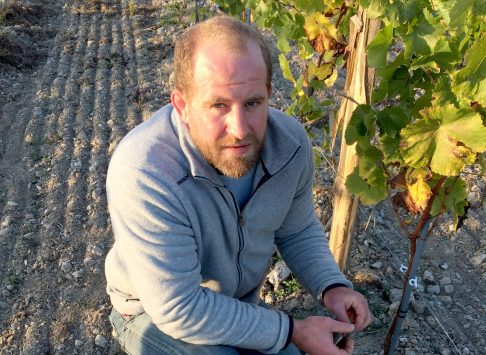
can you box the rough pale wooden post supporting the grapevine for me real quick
[329,7,380,270]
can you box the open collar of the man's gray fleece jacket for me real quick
[171,107,300,187]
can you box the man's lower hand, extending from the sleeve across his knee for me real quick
[292,317,355,355]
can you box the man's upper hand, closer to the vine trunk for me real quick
[322,286,372,332]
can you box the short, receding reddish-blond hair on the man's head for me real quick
[174,15,272,94]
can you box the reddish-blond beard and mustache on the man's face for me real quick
[191,134,264,179]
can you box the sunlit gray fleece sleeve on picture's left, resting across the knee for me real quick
[106,163,289,353]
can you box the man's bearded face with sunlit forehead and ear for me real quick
[172,43,270,178]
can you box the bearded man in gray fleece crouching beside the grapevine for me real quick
[106,17,371,354]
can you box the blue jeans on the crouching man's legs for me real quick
[110,309,300,355]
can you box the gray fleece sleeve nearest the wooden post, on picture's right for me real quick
[275,139,352,302]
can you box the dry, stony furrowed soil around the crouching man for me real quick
[0,0,486,355]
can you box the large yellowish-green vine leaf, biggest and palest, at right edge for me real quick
[400,104,486,176]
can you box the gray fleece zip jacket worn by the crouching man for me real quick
[105,105,351,353]
